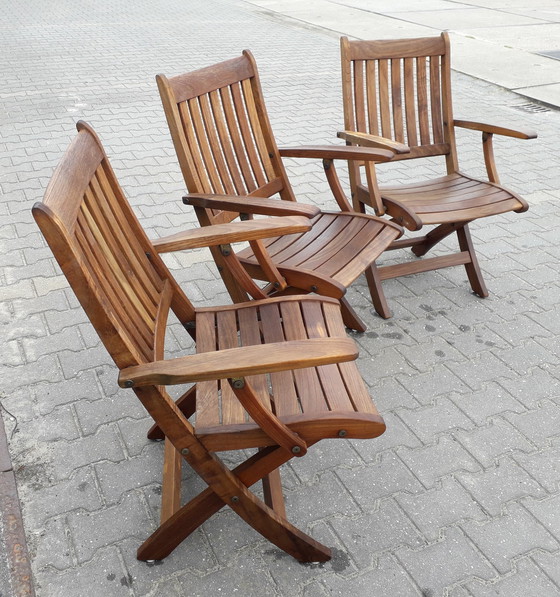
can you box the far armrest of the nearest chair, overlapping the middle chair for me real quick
[152,216,311,253]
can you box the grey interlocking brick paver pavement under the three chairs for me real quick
[0,0,560,597]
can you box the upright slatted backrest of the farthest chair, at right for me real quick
[341,33,457,170]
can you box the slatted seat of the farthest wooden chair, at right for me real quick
[380,172,527,229]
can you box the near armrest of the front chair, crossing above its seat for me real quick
[119,338,358,388]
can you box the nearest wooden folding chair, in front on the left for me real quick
[33,123,385,561]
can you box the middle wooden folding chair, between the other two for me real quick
[156,50,402,331]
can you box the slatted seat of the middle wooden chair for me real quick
[238,212,399,298]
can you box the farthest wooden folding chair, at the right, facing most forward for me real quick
[338,33,537,316]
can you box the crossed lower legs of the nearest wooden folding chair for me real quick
[143,386,331,562]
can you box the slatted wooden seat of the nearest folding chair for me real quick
[195,296,385,451]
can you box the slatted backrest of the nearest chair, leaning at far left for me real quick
[33,122,194,368]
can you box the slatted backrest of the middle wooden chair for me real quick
[156,50,295,223]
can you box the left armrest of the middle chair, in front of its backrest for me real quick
[183,193,320,218]
